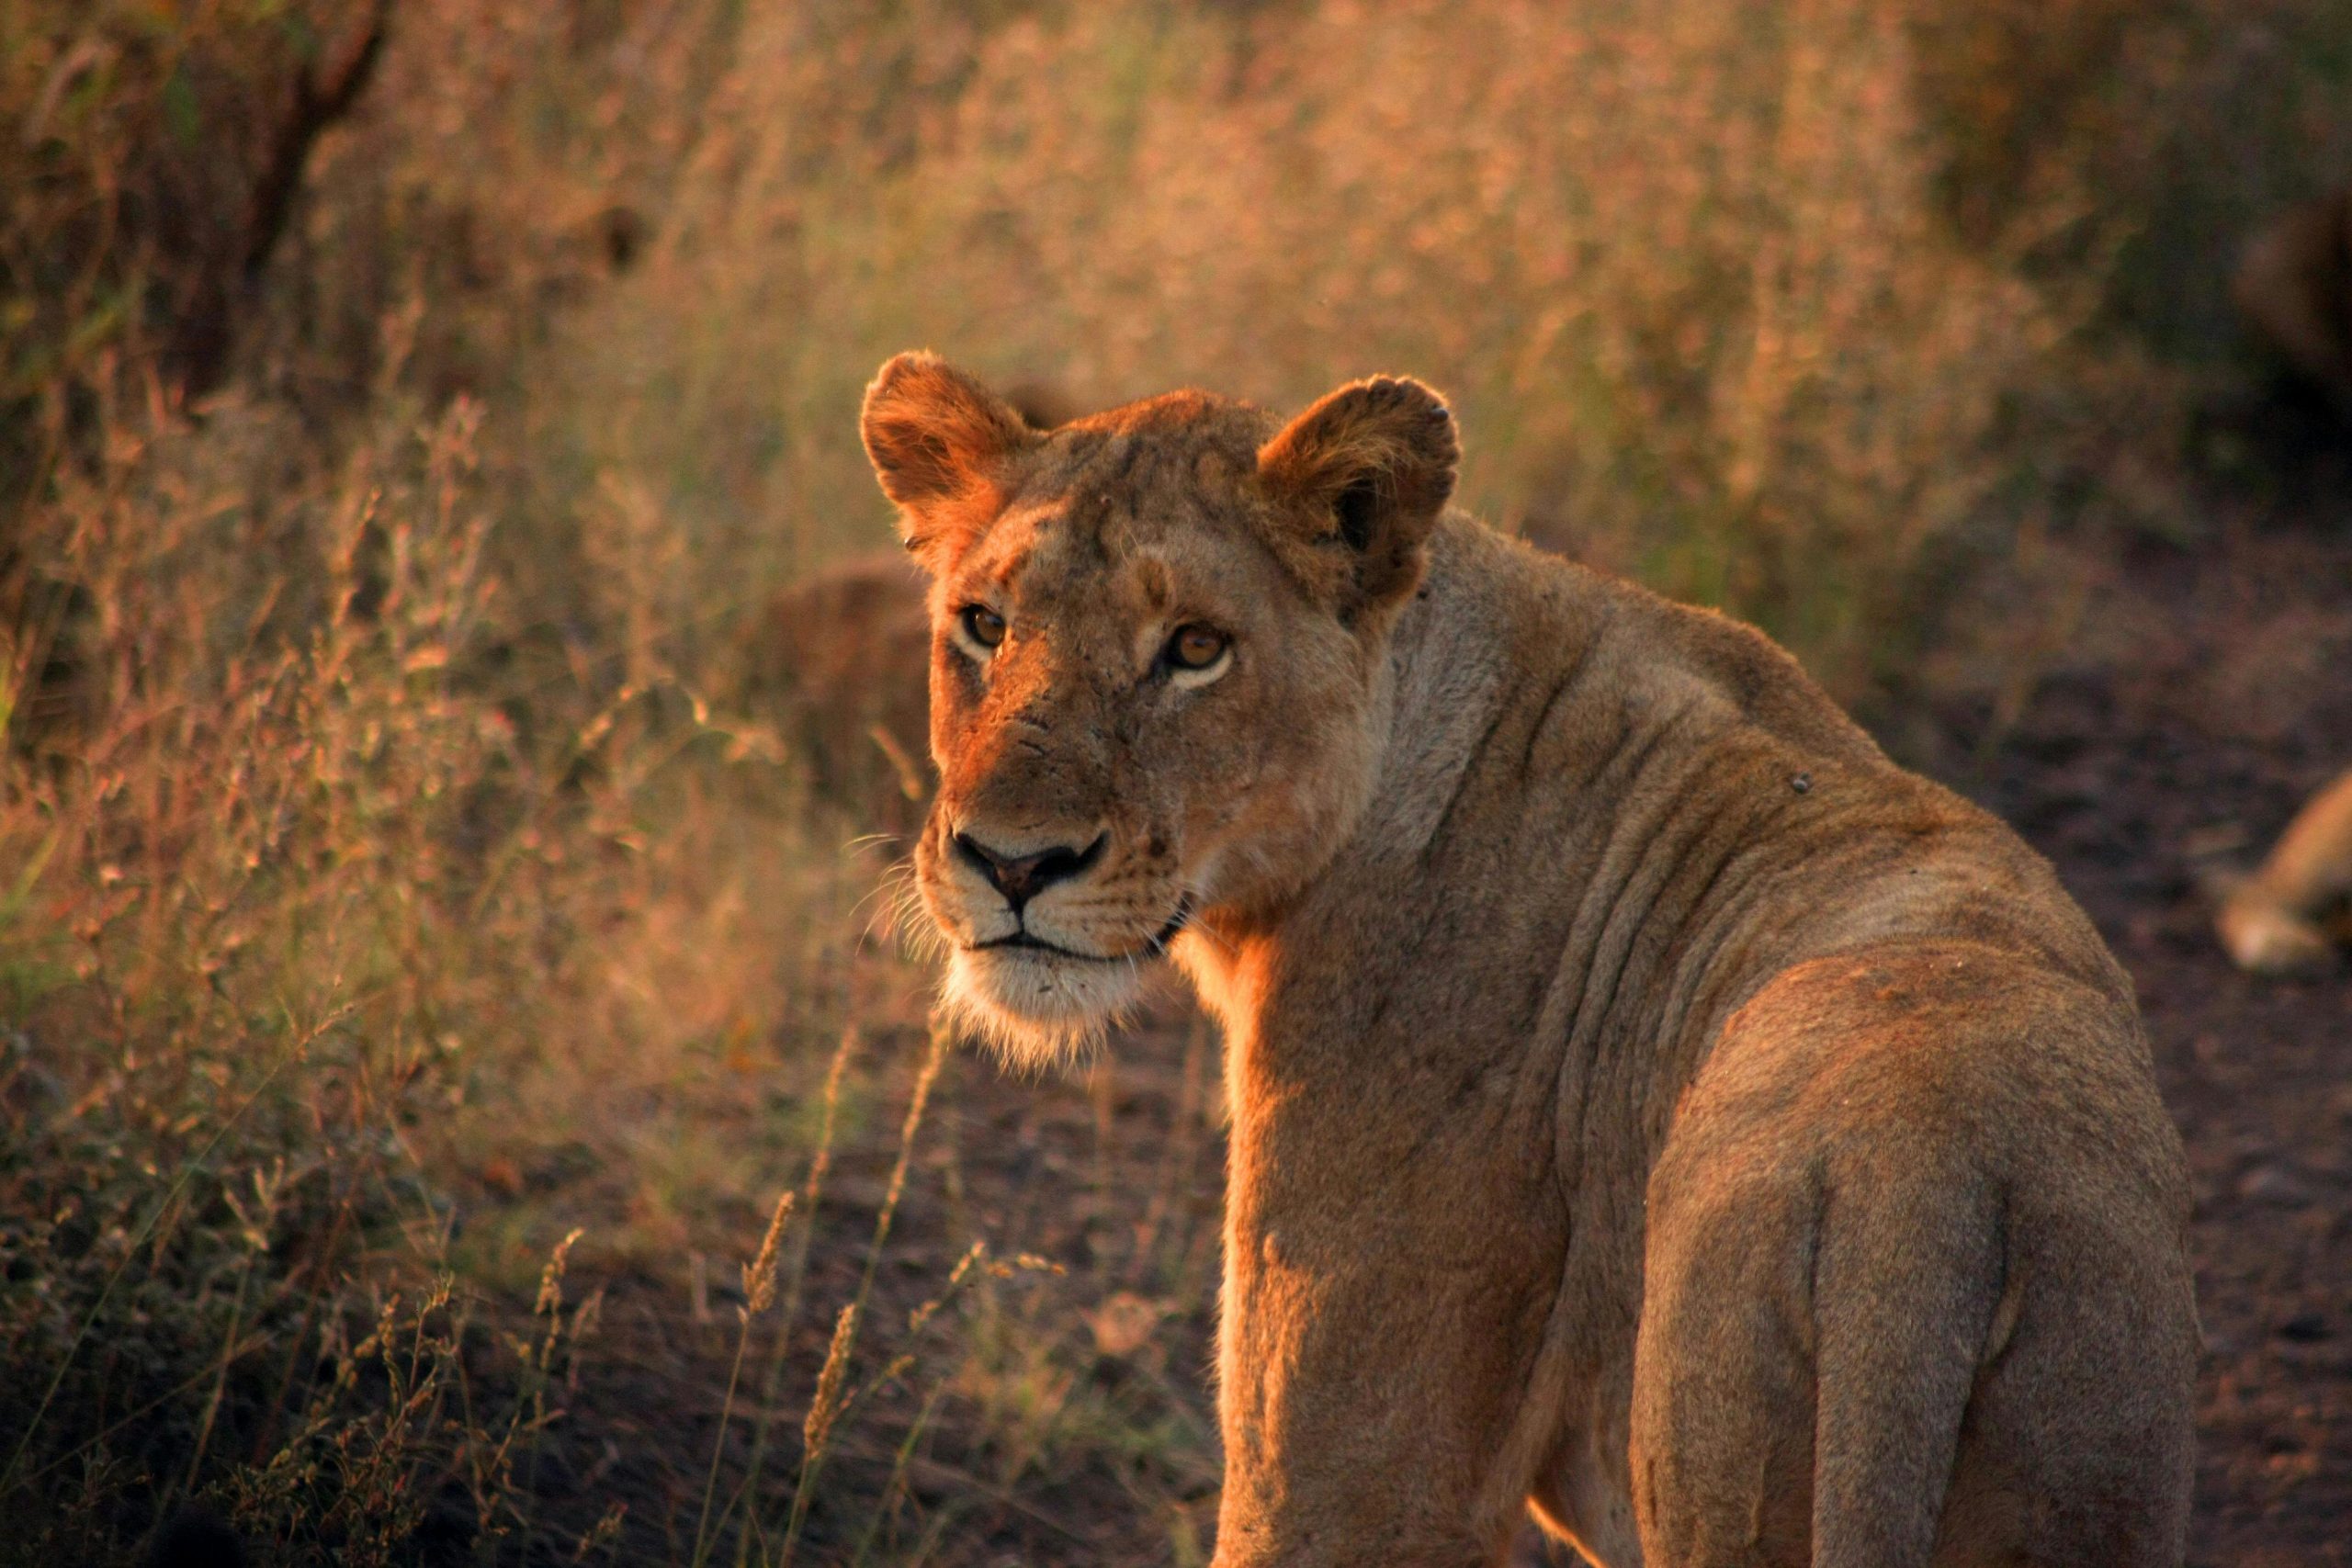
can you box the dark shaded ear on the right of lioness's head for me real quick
[1259,376,1461,616]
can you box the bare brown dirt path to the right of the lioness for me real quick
[1952,489,2352,1568]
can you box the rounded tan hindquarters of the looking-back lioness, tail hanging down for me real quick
[1633,968,2194,1568]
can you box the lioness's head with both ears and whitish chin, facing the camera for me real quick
[865,355,1453,1060]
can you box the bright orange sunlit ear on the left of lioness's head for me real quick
[858,353,1042,552]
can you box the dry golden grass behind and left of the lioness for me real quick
[0,0,2352,1563]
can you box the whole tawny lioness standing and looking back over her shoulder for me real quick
[864,355,2197,1568]
